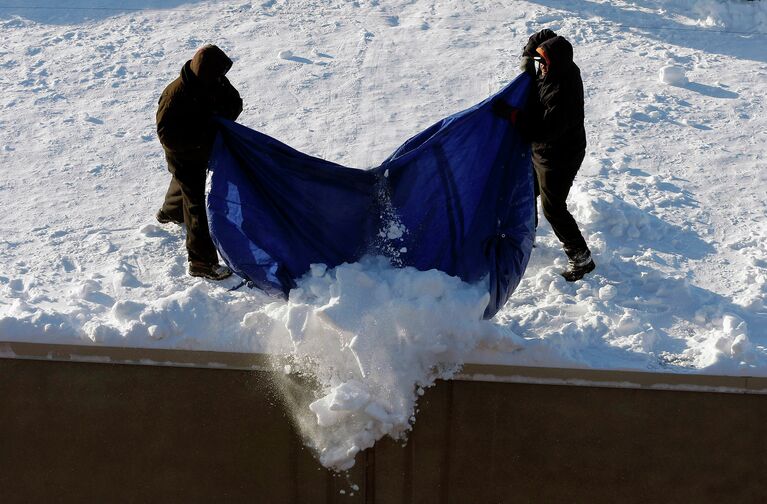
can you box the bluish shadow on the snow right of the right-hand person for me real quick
[587,193,767,373]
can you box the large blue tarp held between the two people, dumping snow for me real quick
[208,74,535,318]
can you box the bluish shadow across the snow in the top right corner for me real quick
[533,0,767,62]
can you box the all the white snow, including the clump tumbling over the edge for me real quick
[0,0,767,468]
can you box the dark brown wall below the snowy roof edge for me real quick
[0,350,767,504]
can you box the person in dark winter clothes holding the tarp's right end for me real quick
[494,30,596,282]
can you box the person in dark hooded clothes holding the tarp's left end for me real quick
[157,45,242,280]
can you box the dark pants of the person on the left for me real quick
[162,160,218,266]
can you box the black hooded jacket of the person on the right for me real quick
[520,35,586,170]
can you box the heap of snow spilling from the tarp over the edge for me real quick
[266,258,519,470]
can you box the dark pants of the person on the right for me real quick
[535,153,588,257]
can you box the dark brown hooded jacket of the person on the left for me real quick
[156,45,242,165]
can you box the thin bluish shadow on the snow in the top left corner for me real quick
[0,0,207,28]
